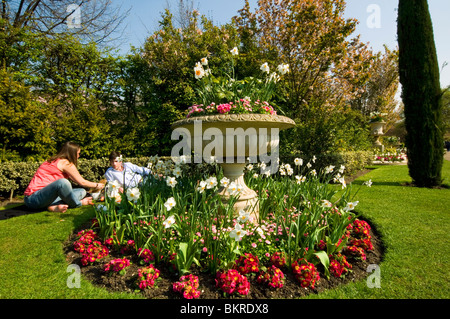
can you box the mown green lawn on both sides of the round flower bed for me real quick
[0,161,450,299]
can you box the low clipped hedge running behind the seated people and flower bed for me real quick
[0,151,373,199]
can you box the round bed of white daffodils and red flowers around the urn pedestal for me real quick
[65,161,380,298]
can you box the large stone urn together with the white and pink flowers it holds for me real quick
[172,48,295,223]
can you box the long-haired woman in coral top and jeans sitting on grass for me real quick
[24,142,105,212]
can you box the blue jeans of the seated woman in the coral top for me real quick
[24,178,86,209]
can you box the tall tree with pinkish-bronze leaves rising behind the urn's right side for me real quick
[239,0,371,118]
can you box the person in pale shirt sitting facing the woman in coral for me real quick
[105,151,152,192]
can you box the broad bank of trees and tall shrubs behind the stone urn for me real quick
[0,0,404,161]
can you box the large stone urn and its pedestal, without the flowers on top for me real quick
[172,114,295,221]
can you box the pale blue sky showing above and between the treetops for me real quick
[112,0,450,87]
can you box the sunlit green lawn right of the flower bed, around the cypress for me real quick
[311,161,450,299]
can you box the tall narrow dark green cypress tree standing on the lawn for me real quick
[397,0,444,187]
